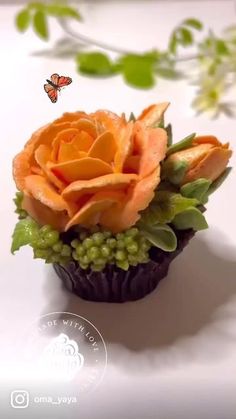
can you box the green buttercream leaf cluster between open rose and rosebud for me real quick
[138,149,231,252]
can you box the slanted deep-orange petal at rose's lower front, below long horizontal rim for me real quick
[66,191,125,230]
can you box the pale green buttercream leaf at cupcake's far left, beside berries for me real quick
[11,218,39,254]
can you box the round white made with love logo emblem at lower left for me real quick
[21,312,107,393]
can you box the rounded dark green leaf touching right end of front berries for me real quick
[141,224,177,252]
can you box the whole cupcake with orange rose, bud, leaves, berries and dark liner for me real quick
[11,103,232,302]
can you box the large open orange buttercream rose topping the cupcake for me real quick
[13,103,168,233]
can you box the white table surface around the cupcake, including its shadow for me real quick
[0,0,236,419]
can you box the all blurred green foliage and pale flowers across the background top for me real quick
[16,0,236,116]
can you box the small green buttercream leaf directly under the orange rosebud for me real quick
[180,178,212,204]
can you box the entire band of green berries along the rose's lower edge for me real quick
[14,192,151,272]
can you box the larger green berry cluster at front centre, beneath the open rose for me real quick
[71,228,151,272]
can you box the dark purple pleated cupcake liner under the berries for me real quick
[54,230,194,303]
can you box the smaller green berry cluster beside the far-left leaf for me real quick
[30,225,71,265]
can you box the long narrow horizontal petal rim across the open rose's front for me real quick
[62,173,138,201]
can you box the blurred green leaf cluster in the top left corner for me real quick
[15,1,81,40]
